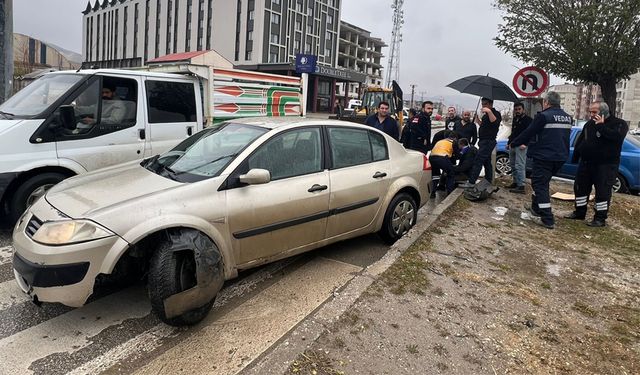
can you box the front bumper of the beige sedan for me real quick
[13,209,128,307]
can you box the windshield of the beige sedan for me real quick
[143,123,268,182]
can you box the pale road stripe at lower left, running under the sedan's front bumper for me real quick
[0,287,151,374]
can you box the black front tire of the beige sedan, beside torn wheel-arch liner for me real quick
[147,235,220,326]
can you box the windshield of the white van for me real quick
[0,74,84,118]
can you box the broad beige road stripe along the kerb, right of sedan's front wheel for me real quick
[132,258,361,375]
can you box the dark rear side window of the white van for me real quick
[145,80,197,124]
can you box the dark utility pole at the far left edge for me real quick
[0,0,13,103]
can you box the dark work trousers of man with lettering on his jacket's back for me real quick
[531,159,564,225]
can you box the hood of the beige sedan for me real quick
[45,163,182,218]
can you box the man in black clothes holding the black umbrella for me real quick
[461,98,502,188]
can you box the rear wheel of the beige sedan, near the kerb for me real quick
[378,193,418,245]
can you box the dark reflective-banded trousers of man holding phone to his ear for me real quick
[573,161,618,220]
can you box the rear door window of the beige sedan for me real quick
[329,128,373,168]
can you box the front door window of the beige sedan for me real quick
[248,128,322,180]
